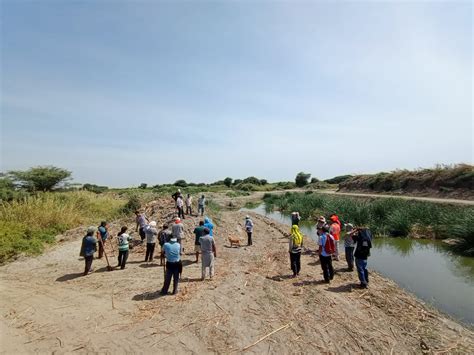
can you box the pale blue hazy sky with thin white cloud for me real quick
[0,0,474,187]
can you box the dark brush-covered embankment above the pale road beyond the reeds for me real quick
[339,164,474,197]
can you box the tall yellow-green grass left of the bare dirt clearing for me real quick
[0,191,125,263]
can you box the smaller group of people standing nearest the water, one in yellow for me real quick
[289,212,372,288]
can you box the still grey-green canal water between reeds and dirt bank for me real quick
[244,204,474,326]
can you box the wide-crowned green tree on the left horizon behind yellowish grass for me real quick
[8,166,71,191]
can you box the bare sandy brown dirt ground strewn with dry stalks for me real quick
[0,199,474,354]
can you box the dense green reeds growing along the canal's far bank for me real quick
[264,192,474,256]
